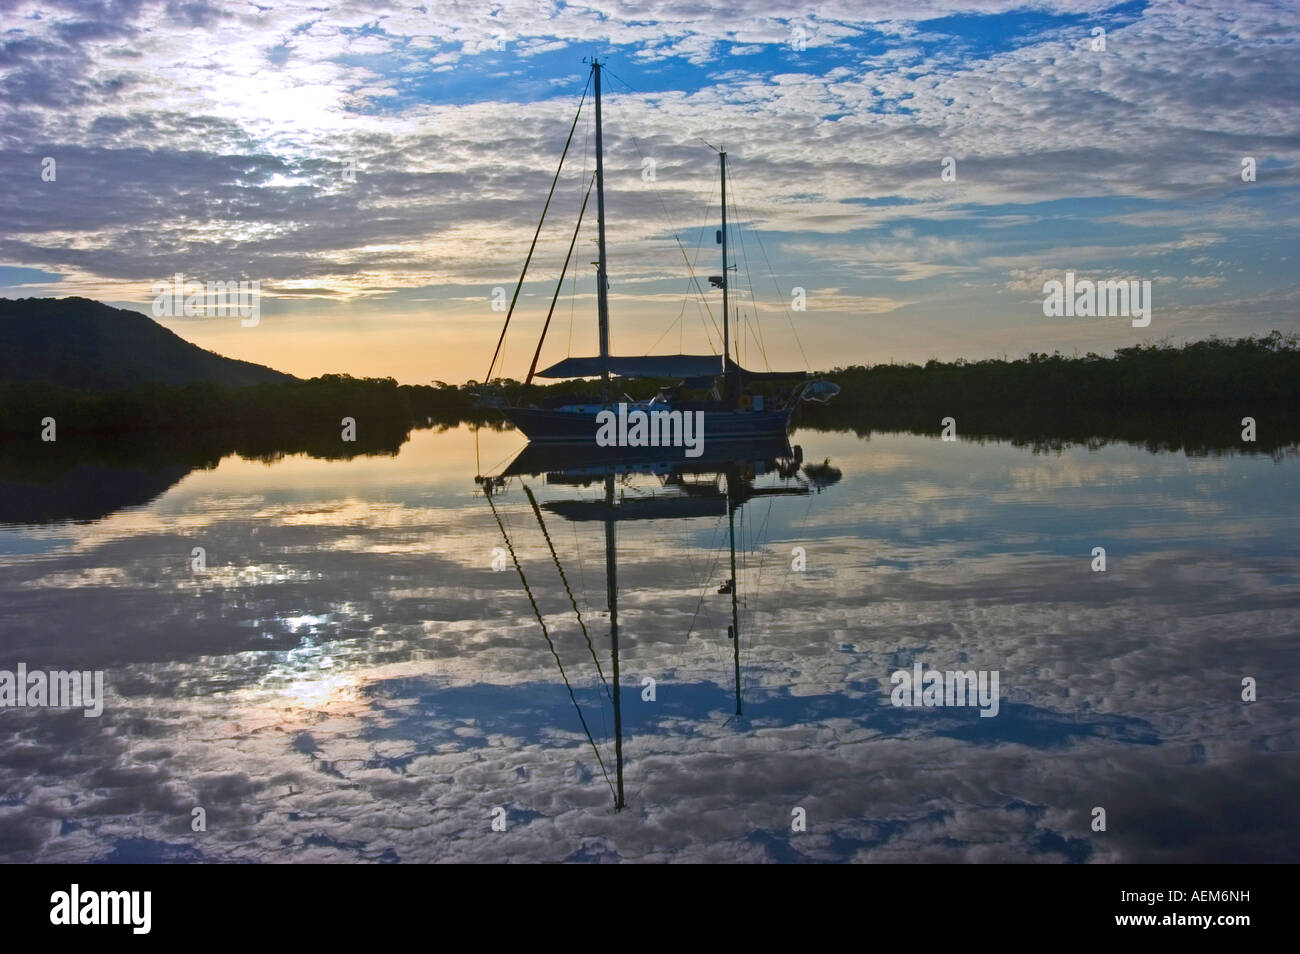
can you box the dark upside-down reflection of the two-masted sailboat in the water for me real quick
[475,437,841,811]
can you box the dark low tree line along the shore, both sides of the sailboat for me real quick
[0,331,1300,471]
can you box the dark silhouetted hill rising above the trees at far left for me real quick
[0,298,295,391]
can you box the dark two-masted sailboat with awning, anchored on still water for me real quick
[489,58,840,447]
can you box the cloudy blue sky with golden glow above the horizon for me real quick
[0,0,1300,381]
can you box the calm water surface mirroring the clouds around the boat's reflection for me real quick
[0,429,1300,862]
